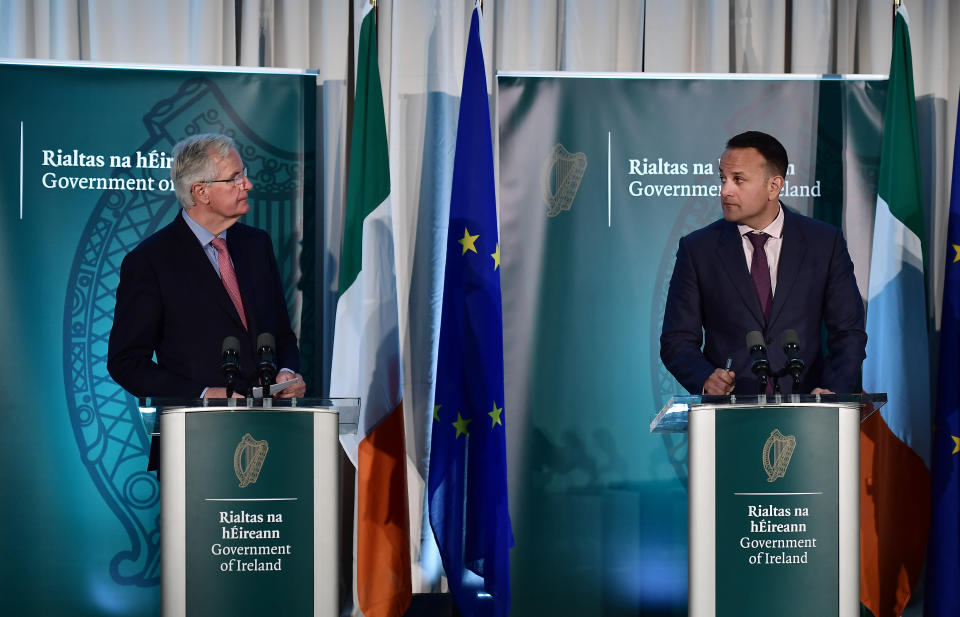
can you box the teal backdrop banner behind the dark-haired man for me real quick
[497,74,886,616]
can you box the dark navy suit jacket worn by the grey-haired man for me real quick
[107,212,300,398]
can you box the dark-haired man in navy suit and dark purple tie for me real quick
[660,131,867,394]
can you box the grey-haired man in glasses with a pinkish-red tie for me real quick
[107,134,306,398]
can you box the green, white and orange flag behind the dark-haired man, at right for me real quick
[860,5,931,617]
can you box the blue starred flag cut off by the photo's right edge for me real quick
[924,94,960,616]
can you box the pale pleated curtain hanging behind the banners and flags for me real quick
[0,0,960,608]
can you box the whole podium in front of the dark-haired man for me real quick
[650,394,886,617]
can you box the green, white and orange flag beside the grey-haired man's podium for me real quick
[330,5,411,617]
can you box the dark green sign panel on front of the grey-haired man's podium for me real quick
[188,411,314,615]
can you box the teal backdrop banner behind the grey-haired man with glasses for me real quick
[0,63,318,616]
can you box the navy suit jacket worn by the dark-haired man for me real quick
[660,208,867,394]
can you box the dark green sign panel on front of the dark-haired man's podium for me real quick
[712,407,840,615]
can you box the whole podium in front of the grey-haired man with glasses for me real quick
[140,399,359,617]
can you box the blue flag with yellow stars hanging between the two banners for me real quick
[429,8,513,617]
